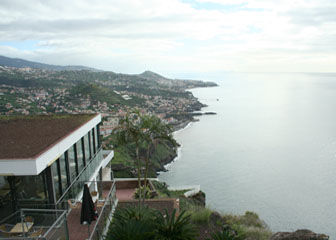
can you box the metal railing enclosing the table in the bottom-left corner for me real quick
[0,209,69,240]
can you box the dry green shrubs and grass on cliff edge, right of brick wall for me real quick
[152,181,272,240]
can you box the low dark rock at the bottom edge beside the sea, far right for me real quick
[270,229,329,240]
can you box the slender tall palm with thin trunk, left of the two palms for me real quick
[113,110,144,203]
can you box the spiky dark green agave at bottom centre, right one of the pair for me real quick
[155,209,196,240]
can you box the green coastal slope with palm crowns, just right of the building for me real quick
[104,112,177,178]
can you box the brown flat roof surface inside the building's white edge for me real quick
[0,114,98,160]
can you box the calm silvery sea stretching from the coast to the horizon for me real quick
[159,73,336,239]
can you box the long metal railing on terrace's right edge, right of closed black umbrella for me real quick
[89,182,117,240]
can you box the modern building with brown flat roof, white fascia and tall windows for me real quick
[0,114,113,223]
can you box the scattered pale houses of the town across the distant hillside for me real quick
[0,84,197,136]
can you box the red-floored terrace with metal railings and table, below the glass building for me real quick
[0,181,118,240]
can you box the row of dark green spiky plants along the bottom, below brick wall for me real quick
[106,207,196,240]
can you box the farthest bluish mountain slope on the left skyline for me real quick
[0,56,100,72]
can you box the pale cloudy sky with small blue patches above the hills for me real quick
[0,0,336,77]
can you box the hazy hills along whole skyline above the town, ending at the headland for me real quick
[0,56,217,92]
